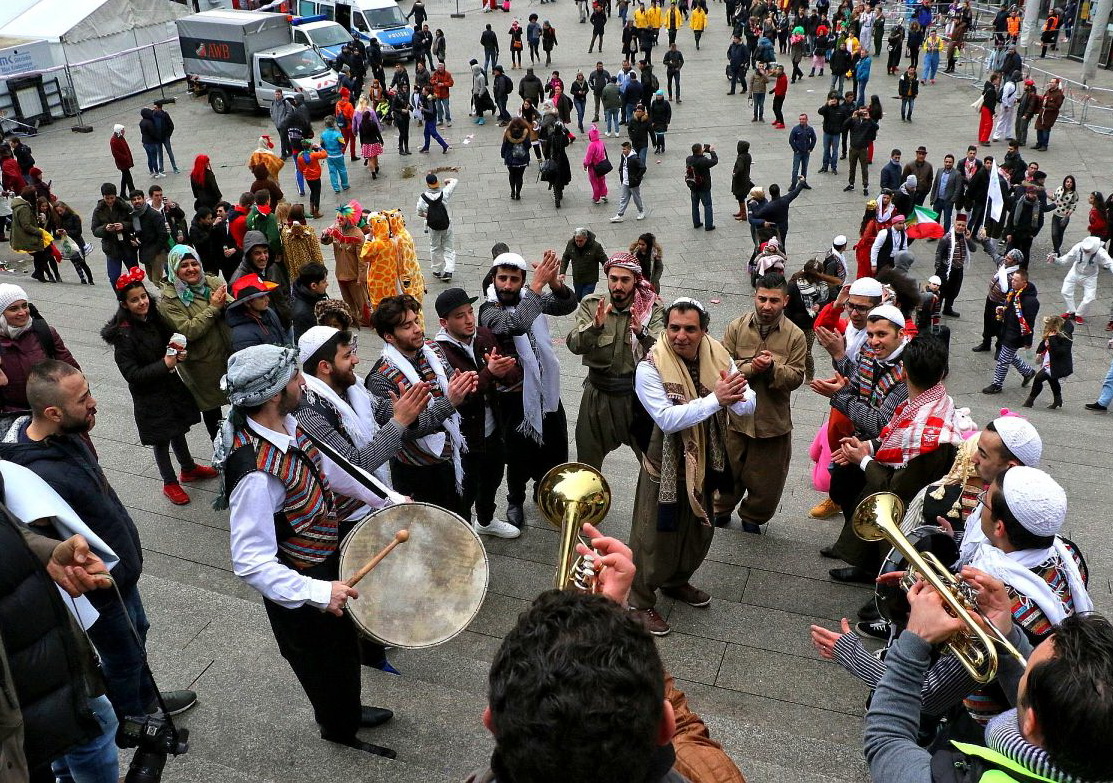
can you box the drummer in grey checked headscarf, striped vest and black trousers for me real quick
[213,345,395,759]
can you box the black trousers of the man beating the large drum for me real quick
[263,556,361,741]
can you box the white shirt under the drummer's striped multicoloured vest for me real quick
[228,416,383,609]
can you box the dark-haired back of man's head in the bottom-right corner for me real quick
[1018,613,1113,781]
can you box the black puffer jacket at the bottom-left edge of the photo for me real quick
[0,489,102,780]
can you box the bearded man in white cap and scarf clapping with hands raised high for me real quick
[480,250,579,527]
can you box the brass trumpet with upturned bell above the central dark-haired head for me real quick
[538,463,611,593]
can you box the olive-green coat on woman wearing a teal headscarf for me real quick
[158,275,232,410]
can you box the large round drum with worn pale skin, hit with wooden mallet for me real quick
[341,503,489,650]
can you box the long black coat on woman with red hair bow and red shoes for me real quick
[100,301,201,446]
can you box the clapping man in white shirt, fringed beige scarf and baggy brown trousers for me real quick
[629,297,757,636]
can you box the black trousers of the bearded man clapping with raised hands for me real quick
[499,392,568,505]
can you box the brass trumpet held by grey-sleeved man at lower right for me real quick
[850,492,1027,683]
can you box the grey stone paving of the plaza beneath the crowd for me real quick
[0,0,1113,783]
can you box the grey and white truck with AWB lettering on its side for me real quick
[176,9,338,115]
